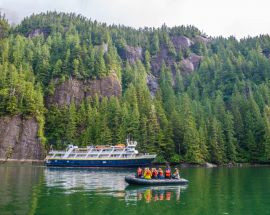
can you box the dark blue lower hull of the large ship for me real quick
[45,158,154,167]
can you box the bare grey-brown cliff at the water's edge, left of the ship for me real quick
[0,116,45,160]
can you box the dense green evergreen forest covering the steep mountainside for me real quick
[0,12,270,164]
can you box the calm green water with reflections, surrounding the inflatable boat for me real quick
[0,164,270,215]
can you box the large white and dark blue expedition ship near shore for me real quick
[45,139,156,167]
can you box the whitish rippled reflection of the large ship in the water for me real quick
[45,168,129,197]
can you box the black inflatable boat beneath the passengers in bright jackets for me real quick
[125,176,188,186]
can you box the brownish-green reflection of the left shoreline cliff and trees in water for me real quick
[0,162,43,214]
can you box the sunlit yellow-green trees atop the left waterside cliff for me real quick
[0,62,46,143]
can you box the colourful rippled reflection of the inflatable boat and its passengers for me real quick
[125,186,187,204]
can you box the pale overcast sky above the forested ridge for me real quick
[0,0,270,38]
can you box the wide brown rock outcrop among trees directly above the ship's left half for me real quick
[47,73,122,106]
